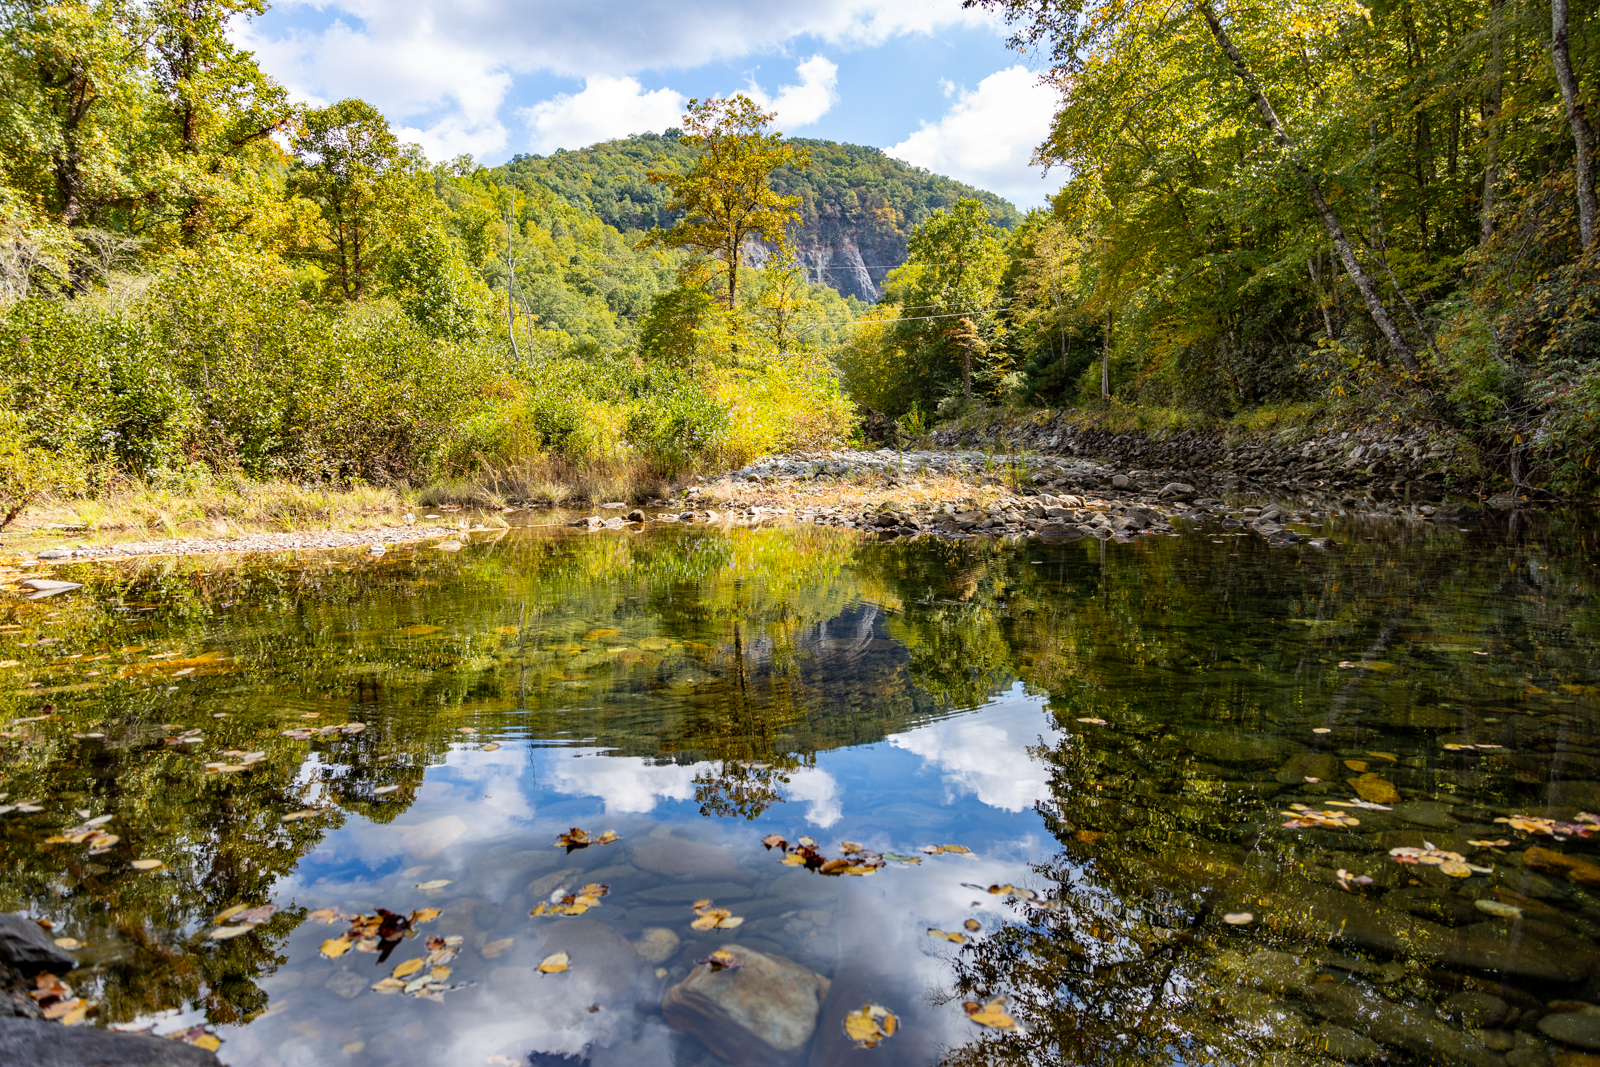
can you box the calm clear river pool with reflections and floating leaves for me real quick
[0,518,1600,1067]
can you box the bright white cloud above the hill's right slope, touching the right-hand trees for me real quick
[885,66,1066,206]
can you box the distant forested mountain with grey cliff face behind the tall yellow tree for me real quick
[491,130,1021,301]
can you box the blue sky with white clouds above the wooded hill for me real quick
[238,0,1064,208]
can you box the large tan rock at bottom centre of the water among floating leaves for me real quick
[661,945,829,1067]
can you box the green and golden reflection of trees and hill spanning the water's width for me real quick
[0,511,1600,1036]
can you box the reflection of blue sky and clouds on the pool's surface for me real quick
[212,689,1054,1067]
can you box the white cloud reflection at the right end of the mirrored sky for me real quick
[888,686,1058,811]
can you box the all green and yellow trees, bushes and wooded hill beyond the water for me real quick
[0,0,1600,531]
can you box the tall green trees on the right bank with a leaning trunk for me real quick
[974,0,1600,488]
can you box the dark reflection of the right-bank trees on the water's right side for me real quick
[928,511,1600,1067]
